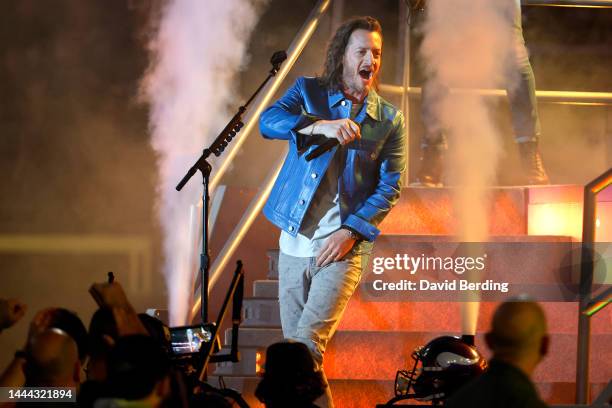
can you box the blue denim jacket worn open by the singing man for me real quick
[259,77,406,241]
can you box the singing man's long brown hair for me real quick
[318,16,382,91]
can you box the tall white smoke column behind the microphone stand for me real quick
[142,0,264,326]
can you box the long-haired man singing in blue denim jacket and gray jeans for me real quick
[260,17,406,406]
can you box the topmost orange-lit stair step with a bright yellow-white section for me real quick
[379,185,612,237]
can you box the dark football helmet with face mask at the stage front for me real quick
[395,336,487,402]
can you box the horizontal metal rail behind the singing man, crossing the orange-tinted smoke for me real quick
[378,84,612,105]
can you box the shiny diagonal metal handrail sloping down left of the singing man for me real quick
[190,0,331,320]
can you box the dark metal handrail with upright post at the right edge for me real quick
[576,168,612,404]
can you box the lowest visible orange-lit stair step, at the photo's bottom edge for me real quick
[208,375,606,408]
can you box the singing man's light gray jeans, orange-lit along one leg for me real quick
[278,251,369,407]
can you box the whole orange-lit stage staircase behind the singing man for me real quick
[209,186,612,408]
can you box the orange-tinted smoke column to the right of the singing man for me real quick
[421,0,517,334]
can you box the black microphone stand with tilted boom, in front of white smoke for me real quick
[176,51,287,324]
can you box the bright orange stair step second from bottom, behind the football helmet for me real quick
[214,331,612,382]
